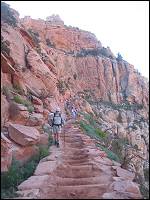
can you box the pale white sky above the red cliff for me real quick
[5,1,149,79]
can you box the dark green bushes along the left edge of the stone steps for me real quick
[1,144,51,198]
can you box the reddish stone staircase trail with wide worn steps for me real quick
[16,121,141,199]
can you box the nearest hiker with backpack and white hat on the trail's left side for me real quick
[52,108,64,147]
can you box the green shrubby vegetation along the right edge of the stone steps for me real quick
[79,112,134,165]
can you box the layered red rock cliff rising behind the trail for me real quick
[1,4,149,196]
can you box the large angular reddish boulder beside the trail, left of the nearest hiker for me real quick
[8,124,40,146]
